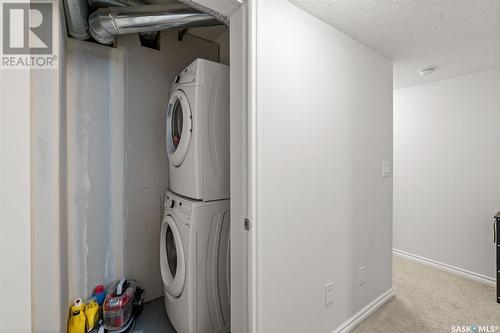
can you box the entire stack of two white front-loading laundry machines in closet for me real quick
[160,59,230,333]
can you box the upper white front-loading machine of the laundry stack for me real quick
[166,59,229,201]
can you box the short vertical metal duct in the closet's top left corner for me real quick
[63,0,90,40]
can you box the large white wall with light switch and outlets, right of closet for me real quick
[255,0,392,332]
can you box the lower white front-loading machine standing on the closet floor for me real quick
[160,192,230,333]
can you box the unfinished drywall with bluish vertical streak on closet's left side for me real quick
[66,39,125,298]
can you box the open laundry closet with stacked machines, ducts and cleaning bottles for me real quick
[61,0,248,333]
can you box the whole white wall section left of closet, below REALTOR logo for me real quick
[0,1,67,332]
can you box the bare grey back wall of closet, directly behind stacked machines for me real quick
[118,31,218,300]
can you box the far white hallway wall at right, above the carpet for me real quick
[394,69,500,279]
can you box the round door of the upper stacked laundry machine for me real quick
[166,90,193,167]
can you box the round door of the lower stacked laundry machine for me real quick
[160,215,186,297]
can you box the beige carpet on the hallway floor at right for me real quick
[352,256,500,333]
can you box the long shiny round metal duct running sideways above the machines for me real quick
[89,5,221,44]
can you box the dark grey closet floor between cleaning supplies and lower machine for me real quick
[132,298,175,333]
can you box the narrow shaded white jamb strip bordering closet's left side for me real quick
[31,50,68,332]
